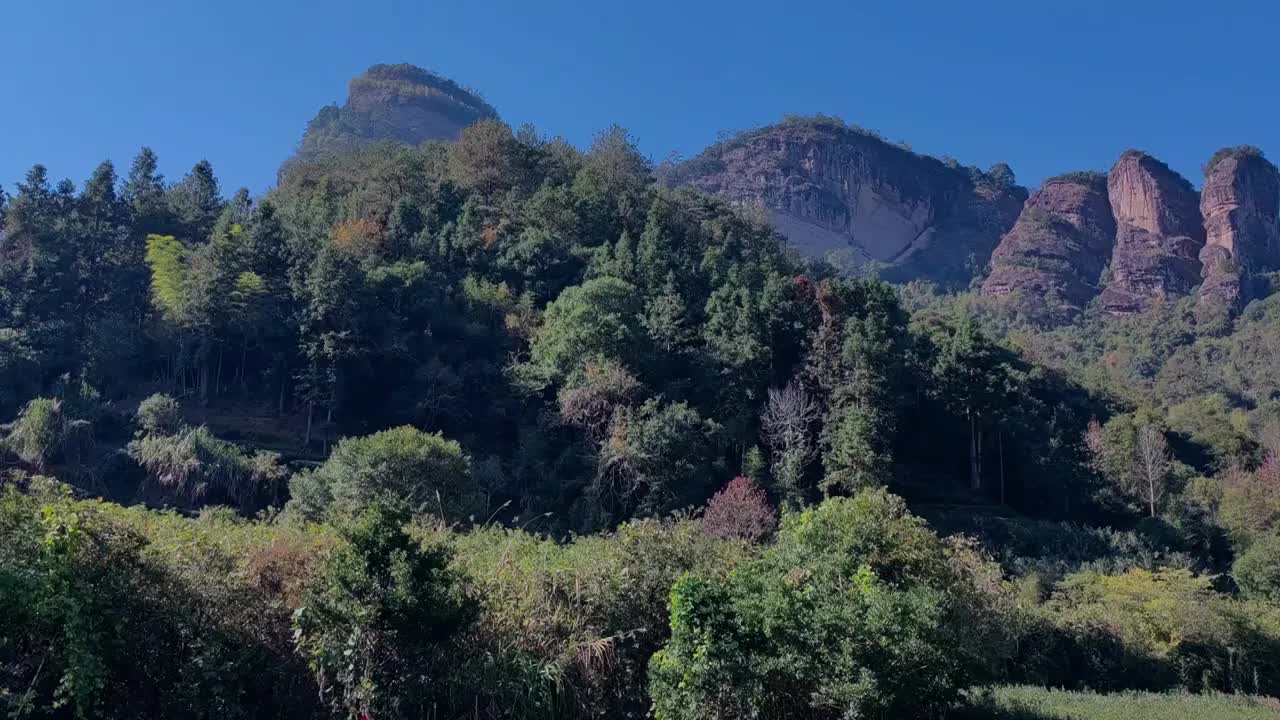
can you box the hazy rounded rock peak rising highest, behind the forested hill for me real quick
[294,65,498,169]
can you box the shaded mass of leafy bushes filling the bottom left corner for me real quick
[0,478,317,720]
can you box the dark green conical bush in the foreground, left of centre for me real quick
[296,505,475,719]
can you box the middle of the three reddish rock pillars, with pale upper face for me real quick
[1102,150,1204,314]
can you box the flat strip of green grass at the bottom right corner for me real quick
[951,687,1280,720]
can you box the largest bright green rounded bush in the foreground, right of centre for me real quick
[650,491,1006,720]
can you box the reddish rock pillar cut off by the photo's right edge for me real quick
[1198,147,1280,313]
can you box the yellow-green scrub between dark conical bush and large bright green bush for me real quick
[452,519,749,719]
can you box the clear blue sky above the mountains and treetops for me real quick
[0,0,1280,193]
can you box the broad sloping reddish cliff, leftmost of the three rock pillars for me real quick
[982,173,1116,320]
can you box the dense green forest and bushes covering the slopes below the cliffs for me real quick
[0,120,1280,720]
